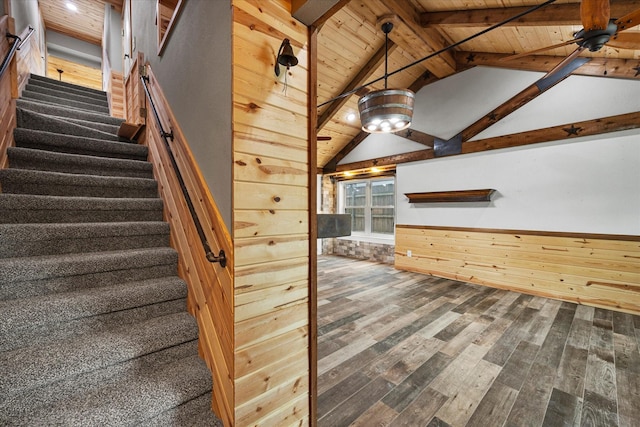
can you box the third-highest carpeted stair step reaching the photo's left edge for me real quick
[0,221,169,258]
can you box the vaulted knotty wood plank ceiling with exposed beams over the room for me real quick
[315,0,640,172]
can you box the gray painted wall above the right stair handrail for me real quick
[131,0,233,230]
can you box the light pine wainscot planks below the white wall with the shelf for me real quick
[395,225,640,314]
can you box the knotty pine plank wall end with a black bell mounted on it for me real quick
[232,0,312,426]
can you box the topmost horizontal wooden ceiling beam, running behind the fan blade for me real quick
[420,0,640,28]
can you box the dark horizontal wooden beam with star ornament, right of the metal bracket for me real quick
[462,112,640,154]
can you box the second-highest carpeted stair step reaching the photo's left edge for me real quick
[0,193,162,224]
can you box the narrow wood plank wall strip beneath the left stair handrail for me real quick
[0,15,17,169]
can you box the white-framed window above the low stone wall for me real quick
[340,178,396,237]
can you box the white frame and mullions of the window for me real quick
[337,175,397,241]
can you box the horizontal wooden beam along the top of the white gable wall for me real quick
[456,52,640,80]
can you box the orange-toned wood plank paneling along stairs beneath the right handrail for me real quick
[140,65,234,426]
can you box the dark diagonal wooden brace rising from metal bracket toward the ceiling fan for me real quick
[461,58,589,143]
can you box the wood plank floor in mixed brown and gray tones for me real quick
[318,256,640,427]
